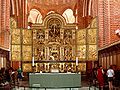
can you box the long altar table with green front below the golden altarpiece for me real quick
[29,73,81,88]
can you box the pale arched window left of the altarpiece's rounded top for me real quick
[28,9,43,23]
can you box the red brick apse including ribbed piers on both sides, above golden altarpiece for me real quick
[10,0,98,28]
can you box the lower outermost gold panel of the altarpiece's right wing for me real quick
[87,45,97,60]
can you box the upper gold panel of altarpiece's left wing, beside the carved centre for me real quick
[22,30,32,44]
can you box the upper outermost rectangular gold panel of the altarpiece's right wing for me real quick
[87,29,97,44]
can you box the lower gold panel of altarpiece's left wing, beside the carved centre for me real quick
[22,45,32,61]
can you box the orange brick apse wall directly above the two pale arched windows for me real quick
[28,0,77,17]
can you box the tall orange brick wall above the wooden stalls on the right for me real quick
[98,0,120,48]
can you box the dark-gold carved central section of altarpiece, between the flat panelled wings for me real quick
[33,14,75,61]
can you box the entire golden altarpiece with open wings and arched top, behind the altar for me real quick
[11,13,97,72]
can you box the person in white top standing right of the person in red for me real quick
[107,66,114,90]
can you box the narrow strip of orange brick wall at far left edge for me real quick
[0,0,10,49]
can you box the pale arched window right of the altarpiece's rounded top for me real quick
[63,9,75,23]
